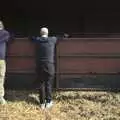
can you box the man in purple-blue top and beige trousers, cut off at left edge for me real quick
[0,21,10,104]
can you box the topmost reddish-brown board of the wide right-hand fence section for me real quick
[58,38,120,55]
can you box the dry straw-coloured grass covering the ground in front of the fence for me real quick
[0,91,120,120]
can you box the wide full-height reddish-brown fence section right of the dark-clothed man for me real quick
[56,38,120,90]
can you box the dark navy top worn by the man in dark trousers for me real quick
[32,37,57,63]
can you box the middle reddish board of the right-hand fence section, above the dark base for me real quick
[59,56,120,74]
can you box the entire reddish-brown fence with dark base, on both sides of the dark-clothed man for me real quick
[5,38,120,90]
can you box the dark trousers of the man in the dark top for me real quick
[37,63,54,103]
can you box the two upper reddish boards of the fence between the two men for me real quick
[7,38,35,73]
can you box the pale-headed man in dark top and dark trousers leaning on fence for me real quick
[32,28,67,109]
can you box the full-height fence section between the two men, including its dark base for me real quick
[5,38,35,89]
